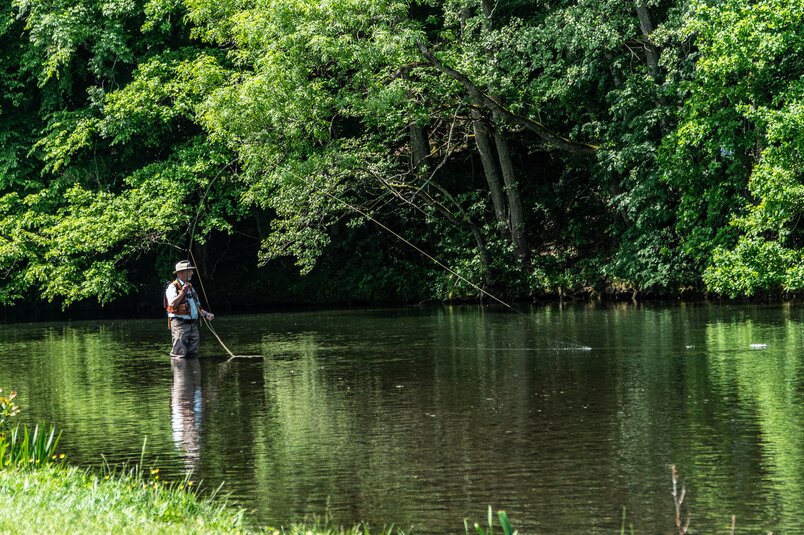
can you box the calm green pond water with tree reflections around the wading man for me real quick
[0,305,804,535]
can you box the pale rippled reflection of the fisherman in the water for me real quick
[170,358,202,470]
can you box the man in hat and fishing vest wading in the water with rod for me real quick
[165,260,215,358]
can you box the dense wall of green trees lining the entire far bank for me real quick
[0,0,804,306]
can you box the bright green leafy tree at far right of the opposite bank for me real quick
[678,0,804,297]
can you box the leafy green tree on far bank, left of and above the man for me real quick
[0,0,241,305]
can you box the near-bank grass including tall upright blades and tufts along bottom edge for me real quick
[0,425,502,535]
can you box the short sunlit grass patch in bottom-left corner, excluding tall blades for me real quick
[0,466,246,534]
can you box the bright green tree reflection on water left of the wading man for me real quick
[0,320,170,464]
